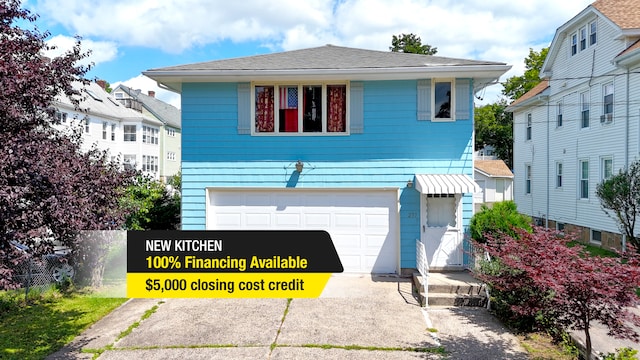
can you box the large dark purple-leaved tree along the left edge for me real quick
[0,0,128,289]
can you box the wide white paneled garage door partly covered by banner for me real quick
[207,189,399,273]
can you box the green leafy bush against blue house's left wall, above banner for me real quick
[121,174,180,230]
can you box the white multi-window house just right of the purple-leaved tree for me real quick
[53,82,162,179]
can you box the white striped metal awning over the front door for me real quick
[416,174,482,194]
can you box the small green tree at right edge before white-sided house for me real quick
[596,160,640,249]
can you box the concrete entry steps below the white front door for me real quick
[413,271,487,307]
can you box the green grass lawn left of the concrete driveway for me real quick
[0,290,127,359]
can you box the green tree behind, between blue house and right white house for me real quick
[474,100,513,168]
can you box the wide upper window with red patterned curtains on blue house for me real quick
[253,83,348,134]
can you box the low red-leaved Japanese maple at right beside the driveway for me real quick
[476,227,640,357]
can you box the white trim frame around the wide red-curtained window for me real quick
[250,80,351,136]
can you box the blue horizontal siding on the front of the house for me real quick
[182,80,473,268]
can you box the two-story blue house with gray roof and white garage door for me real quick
[144,45,510,275]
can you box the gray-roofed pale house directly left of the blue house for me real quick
[111,85,182,181]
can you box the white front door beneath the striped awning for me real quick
[421,194,463,268]
